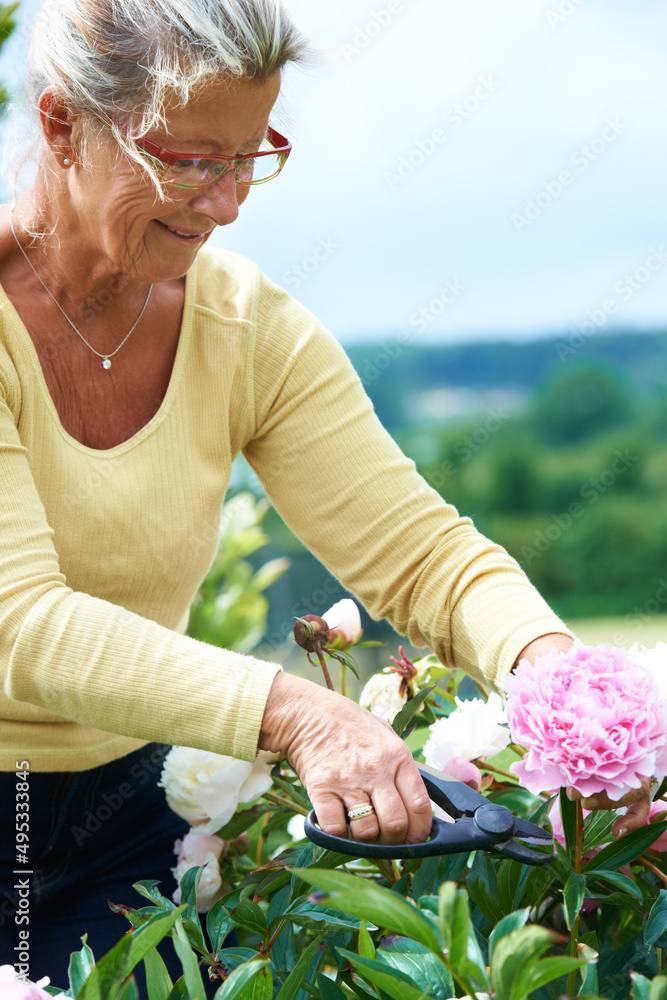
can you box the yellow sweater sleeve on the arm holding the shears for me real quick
[0,372,280,760]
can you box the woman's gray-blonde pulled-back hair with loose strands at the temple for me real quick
[20,0,311,188]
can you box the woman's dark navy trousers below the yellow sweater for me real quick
[0,743,220,1000]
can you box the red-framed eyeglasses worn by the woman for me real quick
[93,112,292,190]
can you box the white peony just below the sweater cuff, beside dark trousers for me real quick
[160,747,272,833]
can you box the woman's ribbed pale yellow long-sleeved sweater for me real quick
[0,250,567,771]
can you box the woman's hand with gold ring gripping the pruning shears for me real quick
[259,673,432,844]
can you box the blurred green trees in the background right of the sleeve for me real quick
[396,360,667,618]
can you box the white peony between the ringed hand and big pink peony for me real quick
[423,693,511,780]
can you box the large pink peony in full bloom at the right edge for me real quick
[505,642,667,801]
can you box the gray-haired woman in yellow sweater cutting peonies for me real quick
[0,0,643,983]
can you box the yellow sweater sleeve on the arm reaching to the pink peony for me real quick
[245,281,570,687]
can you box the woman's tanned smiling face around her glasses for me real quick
[68,72,280,282]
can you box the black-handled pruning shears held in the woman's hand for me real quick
[304,764,553,865]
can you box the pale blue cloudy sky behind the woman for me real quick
[0,0,667,345]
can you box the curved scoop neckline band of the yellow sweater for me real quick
[0,258,197,458]
